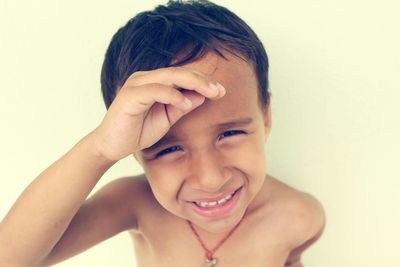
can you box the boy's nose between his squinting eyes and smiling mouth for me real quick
[186,148,232,193]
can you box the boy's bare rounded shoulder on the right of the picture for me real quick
[269,177,325,247]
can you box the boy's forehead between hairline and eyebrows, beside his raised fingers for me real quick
[170,52,261,136]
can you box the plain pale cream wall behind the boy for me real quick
[0,0,400,267]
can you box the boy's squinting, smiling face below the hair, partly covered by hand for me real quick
[137,50,271,233]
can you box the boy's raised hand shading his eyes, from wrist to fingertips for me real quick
[92,67,225,161]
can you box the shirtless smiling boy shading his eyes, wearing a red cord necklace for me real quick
[0,1,324,267]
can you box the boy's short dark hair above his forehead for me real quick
[101,0,269,109]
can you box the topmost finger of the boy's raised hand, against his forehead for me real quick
[127,67,226,99]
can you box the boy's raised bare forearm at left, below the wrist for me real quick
[0,134,114,266]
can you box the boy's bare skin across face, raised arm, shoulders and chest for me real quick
[0,50,324,267]
